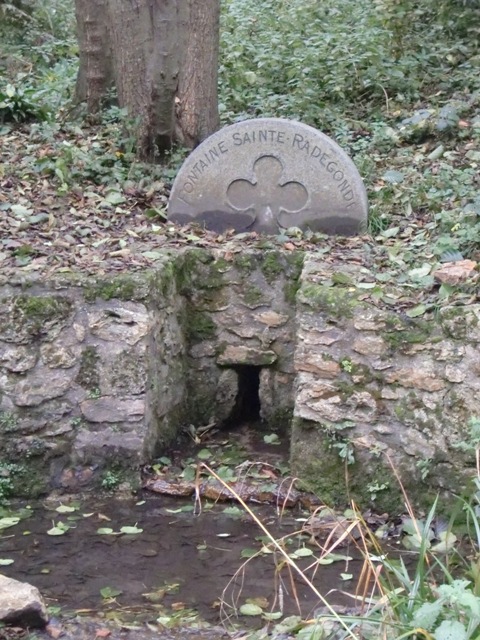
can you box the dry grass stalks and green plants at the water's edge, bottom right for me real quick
[203,418,480,640]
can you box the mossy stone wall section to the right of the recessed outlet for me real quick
[291,256,480,507]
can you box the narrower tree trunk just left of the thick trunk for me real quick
[75,0,113,113]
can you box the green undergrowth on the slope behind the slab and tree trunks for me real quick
[0,0,480,259]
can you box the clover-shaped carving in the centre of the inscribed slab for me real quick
[227,156,308,227]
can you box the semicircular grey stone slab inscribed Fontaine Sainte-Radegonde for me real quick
[168,118,368,235]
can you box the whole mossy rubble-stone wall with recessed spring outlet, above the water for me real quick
[0,249,480,506]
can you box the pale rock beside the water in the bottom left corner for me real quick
[0,574,48,627]
